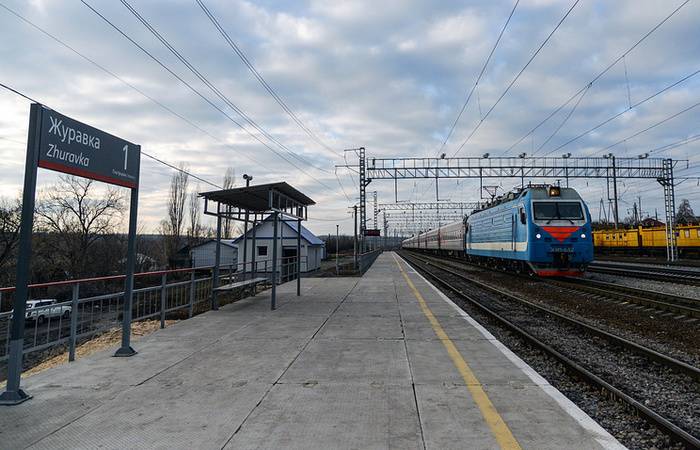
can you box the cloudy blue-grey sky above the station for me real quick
[0,0,700,237]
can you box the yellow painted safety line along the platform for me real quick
[393,255,521,450]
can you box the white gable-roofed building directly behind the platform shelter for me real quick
[233,216,326,276]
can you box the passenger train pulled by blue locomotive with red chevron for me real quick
[402,186,593,276]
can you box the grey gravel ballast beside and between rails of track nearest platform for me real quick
[402,251,700,448]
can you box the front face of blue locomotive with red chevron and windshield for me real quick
[528,186,593,276]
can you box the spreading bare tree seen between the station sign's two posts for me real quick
[36,175,125,277]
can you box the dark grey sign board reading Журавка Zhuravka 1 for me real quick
[37,106,141,189]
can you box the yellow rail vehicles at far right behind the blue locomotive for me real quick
[593,225,700,256]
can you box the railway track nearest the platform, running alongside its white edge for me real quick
[402,253,700,448]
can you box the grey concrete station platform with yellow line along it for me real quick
[0,253,621,449]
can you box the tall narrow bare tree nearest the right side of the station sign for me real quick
[160,163,189,262]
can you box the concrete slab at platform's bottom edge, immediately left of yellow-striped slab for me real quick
[225,383,424,450]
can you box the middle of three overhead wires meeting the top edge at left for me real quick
[115,0,328,179]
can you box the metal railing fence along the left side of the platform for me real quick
[0,253,306,361]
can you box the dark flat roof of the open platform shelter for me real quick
[199,181,316,216]
